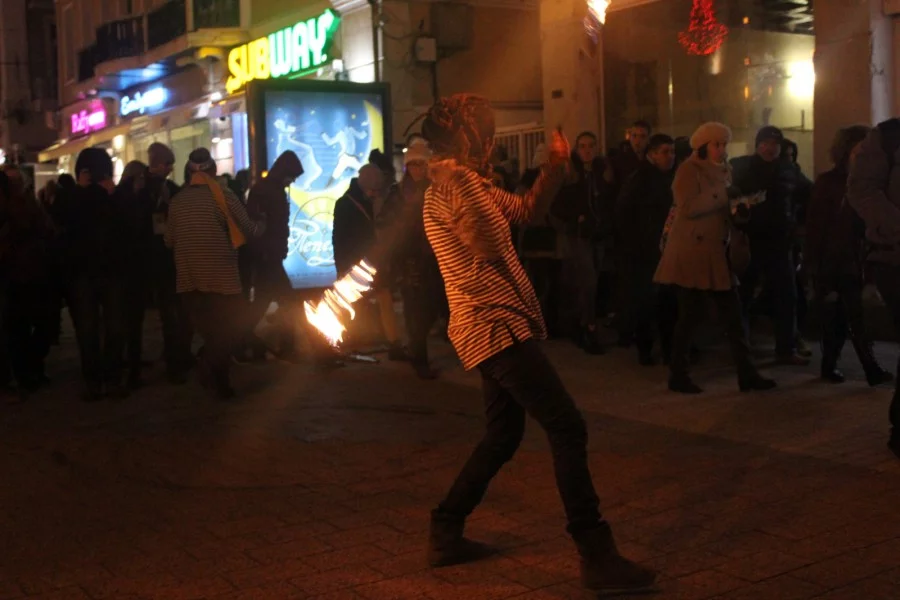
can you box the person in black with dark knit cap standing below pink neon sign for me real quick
[64,148,132,402]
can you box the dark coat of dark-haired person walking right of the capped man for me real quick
[803,168,866,277]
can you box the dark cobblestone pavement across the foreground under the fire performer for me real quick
[0,314,900,600]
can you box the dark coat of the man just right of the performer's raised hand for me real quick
[550,153,615,241]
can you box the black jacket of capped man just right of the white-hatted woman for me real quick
[731,154,796,248]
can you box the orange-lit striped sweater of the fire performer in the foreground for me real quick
[424,165,564,370]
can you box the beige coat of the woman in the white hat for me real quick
[654,154,733,291]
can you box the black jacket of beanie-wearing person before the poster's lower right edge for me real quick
[331,179,376,277]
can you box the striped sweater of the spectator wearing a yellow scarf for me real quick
[165,185,265,294]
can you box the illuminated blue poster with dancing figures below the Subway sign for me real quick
[263,88,385,289]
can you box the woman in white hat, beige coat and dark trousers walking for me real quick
[654,122,775,394]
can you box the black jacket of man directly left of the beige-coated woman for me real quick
[616,161,674,269]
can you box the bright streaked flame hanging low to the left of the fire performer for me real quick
[303,260,375,346]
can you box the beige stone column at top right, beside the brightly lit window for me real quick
[813,0,900,173]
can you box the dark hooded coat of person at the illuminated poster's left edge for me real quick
[247,152,303,262]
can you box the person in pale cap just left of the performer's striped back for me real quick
[382,140,446,379]
